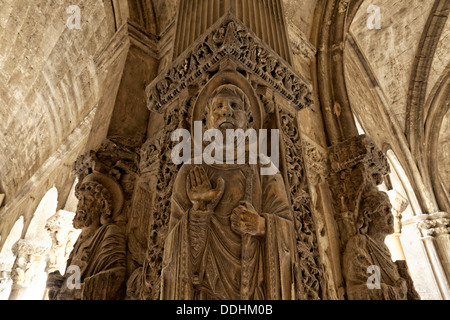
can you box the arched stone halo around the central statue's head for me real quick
[191,70,262,133]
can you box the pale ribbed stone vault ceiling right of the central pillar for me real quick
[344,0,450,210]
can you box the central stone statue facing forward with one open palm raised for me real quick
[161,84,296,300]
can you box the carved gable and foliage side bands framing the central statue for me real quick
[134,14,324,299]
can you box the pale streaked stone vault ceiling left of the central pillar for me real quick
[0,0,176,205]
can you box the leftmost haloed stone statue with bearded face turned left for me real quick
[47,173,126,300]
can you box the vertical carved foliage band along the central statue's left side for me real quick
[128,99,191,300]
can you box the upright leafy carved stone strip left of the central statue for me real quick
[133,97,193,300]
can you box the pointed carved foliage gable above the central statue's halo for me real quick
[147,13,313,116]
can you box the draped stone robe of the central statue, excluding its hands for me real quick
[161,164,296,300]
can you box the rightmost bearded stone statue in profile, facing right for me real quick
[343,190,419,300]
